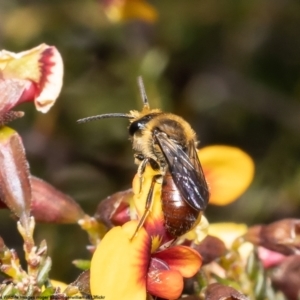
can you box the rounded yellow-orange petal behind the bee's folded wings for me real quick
[198,145,254,205]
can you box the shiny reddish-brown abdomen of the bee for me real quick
[161,173,199,236]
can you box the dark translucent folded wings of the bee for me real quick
[155,132,209,211]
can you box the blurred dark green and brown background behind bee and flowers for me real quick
[0,0,300,282]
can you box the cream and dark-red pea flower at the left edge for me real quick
[0,44,63,124]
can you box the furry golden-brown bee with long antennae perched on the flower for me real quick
[78,77,209,237]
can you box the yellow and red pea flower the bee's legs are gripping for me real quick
[90,167,202,300]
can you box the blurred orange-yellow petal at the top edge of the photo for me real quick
[106,0,157,22]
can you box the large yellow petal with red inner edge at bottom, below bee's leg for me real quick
[90,221,151,300]
